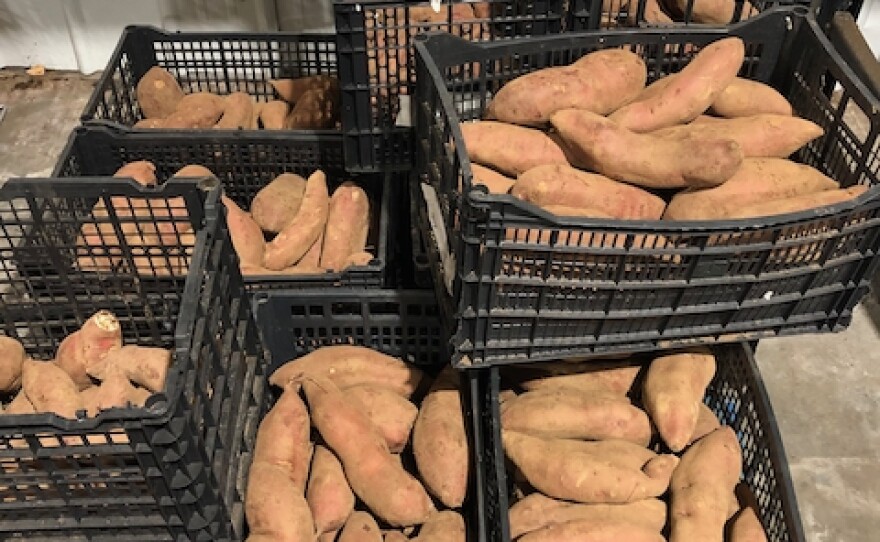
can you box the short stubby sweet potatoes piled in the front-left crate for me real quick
[0,310,171,419]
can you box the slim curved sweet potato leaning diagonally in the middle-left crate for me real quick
[263,170,330,269]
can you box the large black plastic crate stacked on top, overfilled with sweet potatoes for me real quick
[416,8,880,367]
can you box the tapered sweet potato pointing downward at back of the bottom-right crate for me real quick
[642,350,715,452]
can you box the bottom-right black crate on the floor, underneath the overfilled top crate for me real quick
[478,343,806,542]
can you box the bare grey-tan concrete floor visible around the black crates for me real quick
[0,70,880,542]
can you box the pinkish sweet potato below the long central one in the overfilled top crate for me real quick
[510,165,666,220]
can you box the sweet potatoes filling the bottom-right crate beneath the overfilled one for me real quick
[500,349,767,542]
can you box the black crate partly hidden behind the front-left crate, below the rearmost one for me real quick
[50,126,388,291]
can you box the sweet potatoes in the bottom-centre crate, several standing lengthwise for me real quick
[245,345,470,542]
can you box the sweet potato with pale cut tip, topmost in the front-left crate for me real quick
[55,310,122,389]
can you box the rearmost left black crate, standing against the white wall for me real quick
[80,26,338,137]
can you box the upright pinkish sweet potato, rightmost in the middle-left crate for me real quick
[320,185,370,272]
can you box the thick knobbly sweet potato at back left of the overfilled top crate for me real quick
[486,49,647,127]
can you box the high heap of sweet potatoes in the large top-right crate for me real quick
[461,37,867,225]
